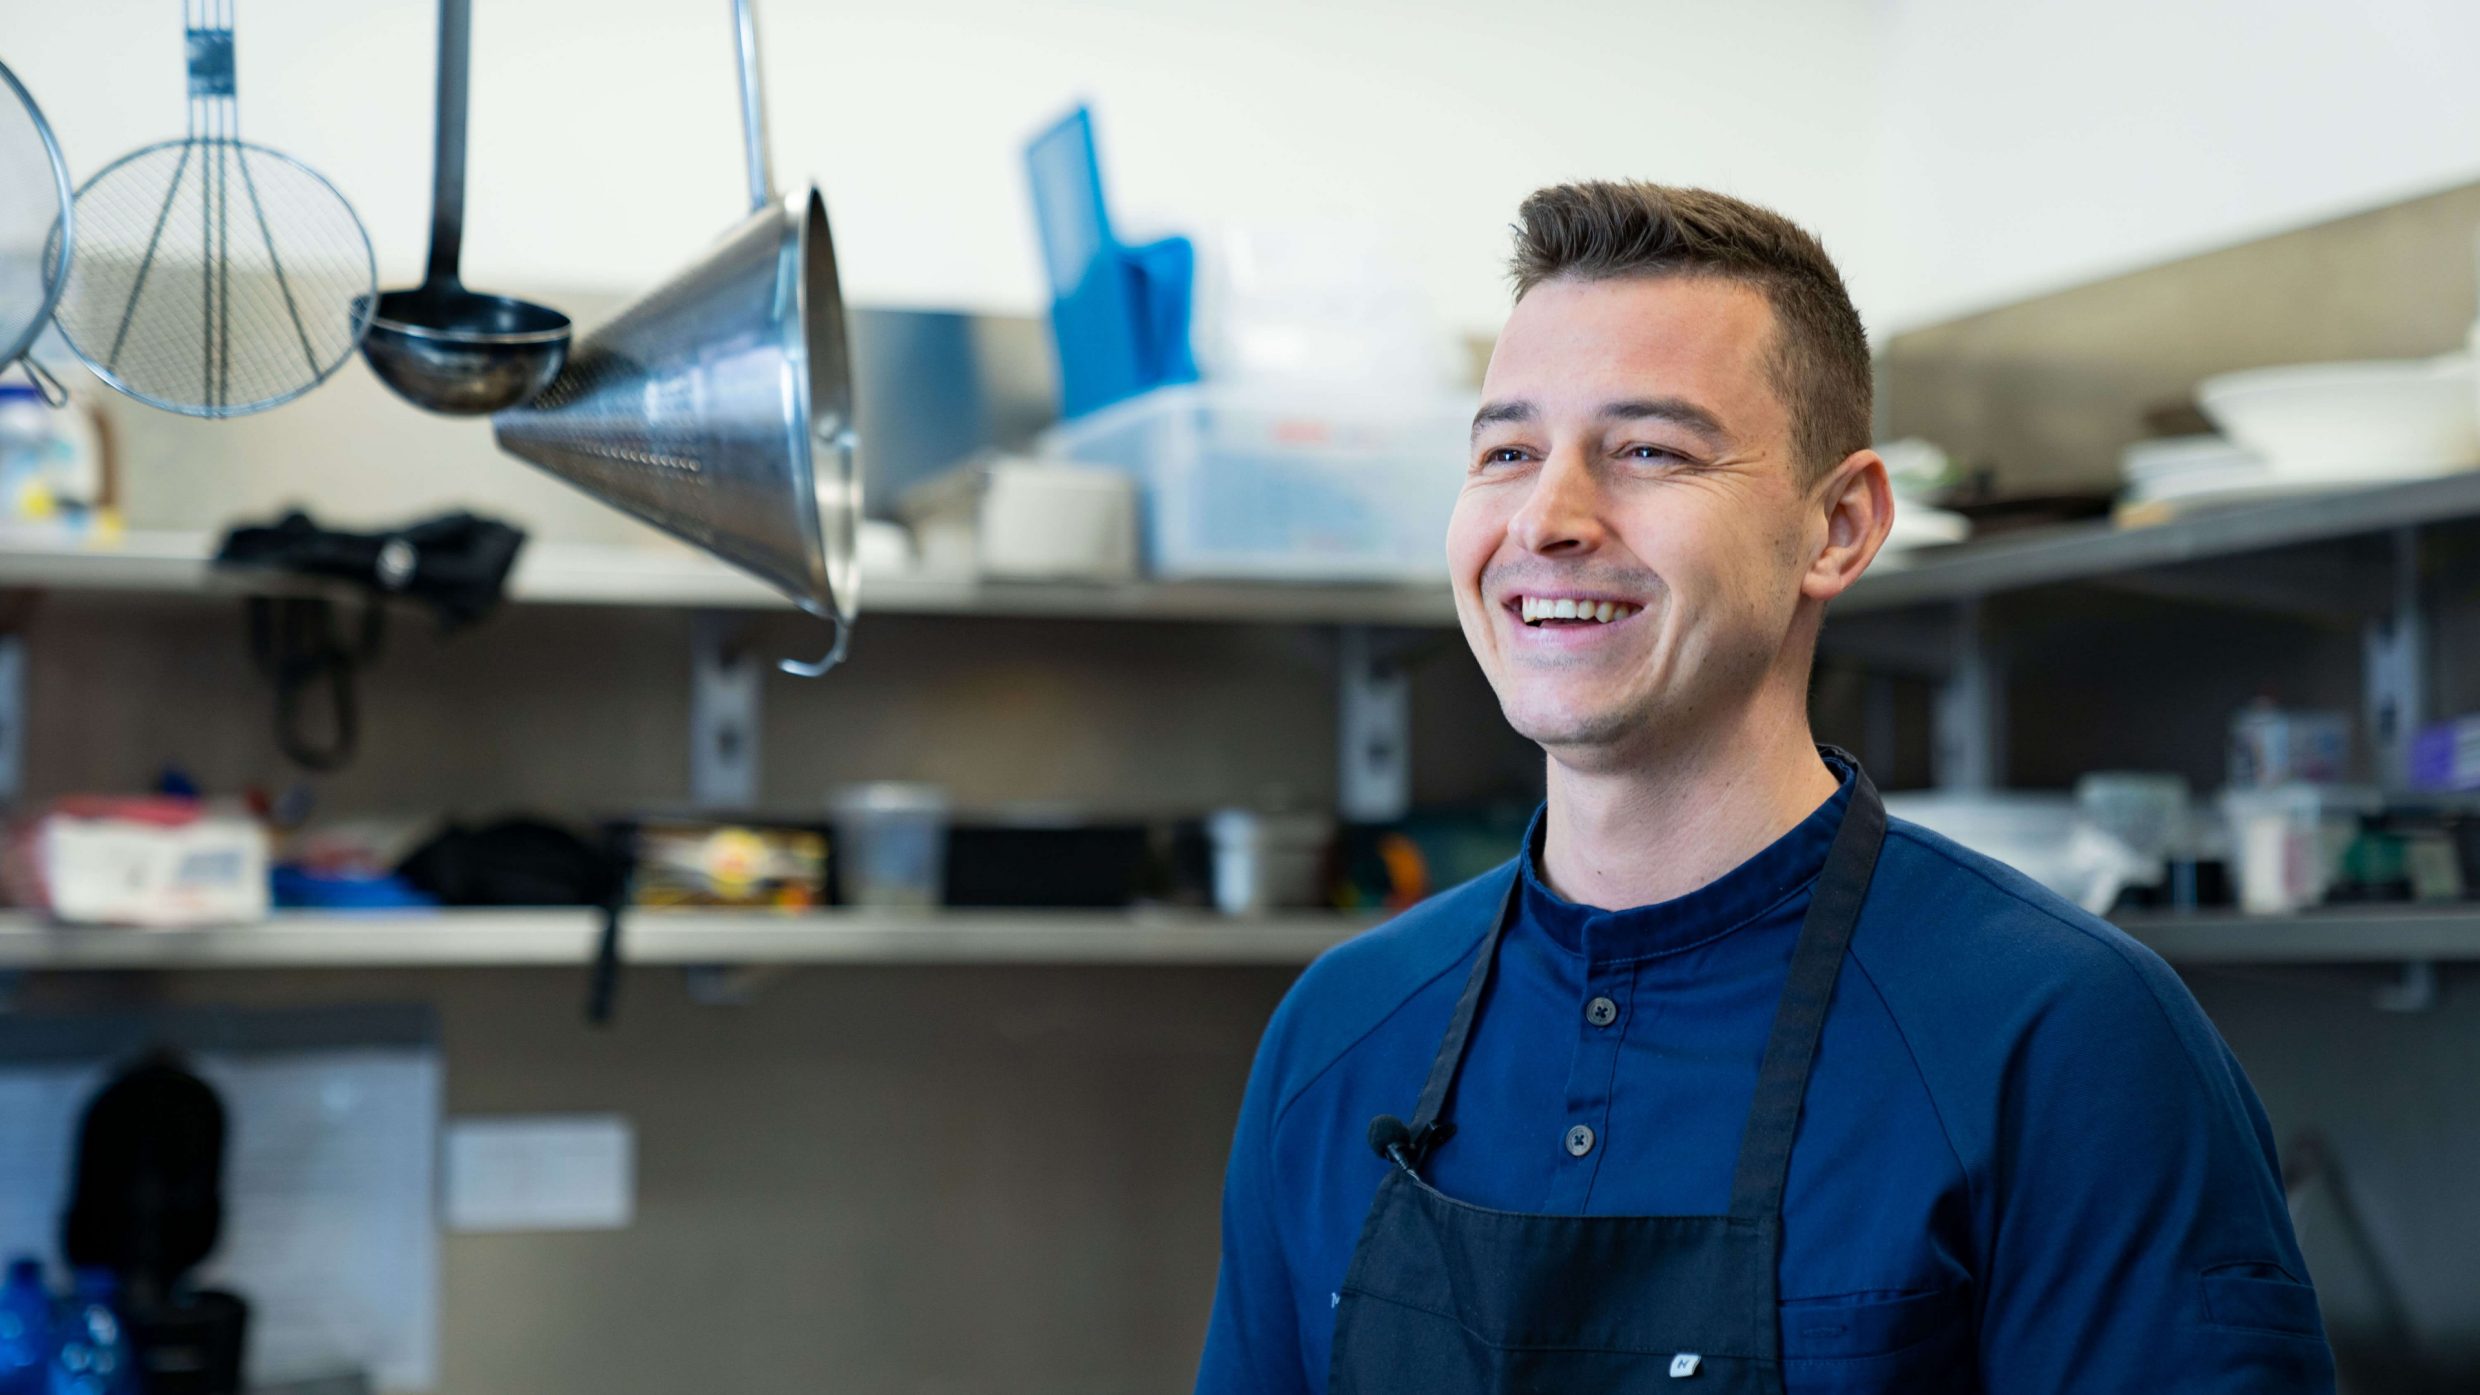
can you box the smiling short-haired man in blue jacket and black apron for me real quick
[1198,184,2334,1395]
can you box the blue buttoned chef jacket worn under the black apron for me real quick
[1198,774,2334,1395]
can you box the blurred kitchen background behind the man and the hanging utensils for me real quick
[0,0,2480,1395]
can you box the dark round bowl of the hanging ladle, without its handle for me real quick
[362,280,570,417]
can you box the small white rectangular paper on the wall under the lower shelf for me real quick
[441,1115,637,1231]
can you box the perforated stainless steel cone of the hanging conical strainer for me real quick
[491,189,861,621]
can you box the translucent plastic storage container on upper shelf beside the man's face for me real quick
[1042,382,1473,581]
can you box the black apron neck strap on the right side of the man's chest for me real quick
[1731,752,1885,1216]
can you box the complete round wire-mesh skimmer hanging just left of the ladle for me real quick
[55,0,379,417]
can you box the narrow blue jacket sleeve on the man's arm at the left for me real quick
[1198,1003,1309,1395]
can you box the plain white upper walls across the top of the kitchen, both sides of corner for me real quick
[19,0,2480,330]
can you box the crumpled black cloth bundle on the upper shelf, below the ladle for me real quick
[216,509,526,628]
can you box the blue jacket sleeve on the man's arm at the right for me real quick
[1982,951,2334,1395]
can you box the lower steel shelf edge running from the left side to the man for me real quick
[0,908,1374,971]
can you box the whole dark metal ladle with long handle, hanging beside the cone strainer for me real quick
[362,0,568,417]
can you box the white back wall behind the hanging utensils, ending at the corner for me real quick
[0,0,1880,328]
